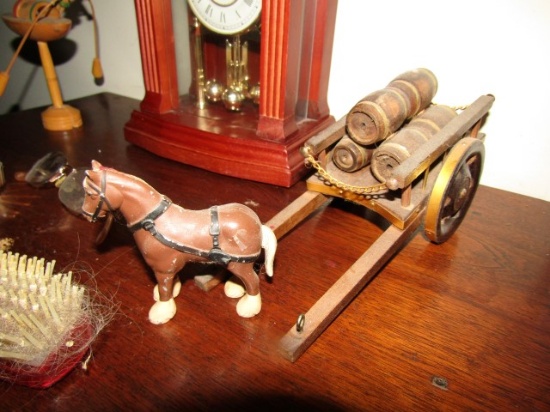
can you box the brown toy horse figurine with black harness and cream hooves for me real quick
[82,161,277,324]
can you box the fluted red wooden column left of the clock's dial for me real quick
[134,0,179,113]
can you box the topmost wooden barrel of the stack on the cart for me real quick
[346,69,437,145]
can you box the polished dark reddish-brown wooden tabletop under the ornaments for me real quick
[0,94,550,411]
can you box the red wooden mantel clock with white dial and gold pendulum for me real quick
[124,0,337,187]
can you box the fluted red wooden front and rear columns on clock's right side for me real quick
[257,0,338,141]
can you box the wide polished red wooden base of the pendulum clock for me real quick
[124,102,334,187]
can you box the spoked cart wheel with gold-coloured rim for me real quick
[424,137,485,243]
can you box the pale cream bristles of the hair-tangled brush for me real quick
[0,251,85,366]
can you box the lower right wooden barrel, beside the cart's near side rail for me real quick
[371,105,457,182]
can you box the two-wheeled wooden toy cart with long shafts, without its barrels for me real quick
[267,95,494,361]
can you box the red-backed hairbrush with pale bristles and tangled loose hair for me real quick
[0,250,98,388]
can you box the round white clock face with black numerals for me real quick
[188,0,262,35]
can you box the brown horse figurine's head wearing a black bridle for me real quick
[82,160,123,222]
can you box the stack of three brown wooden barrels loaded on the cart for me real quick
[332,68,456,181]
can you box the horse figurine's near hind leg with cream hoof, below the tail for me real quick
[227,262,262,318]
